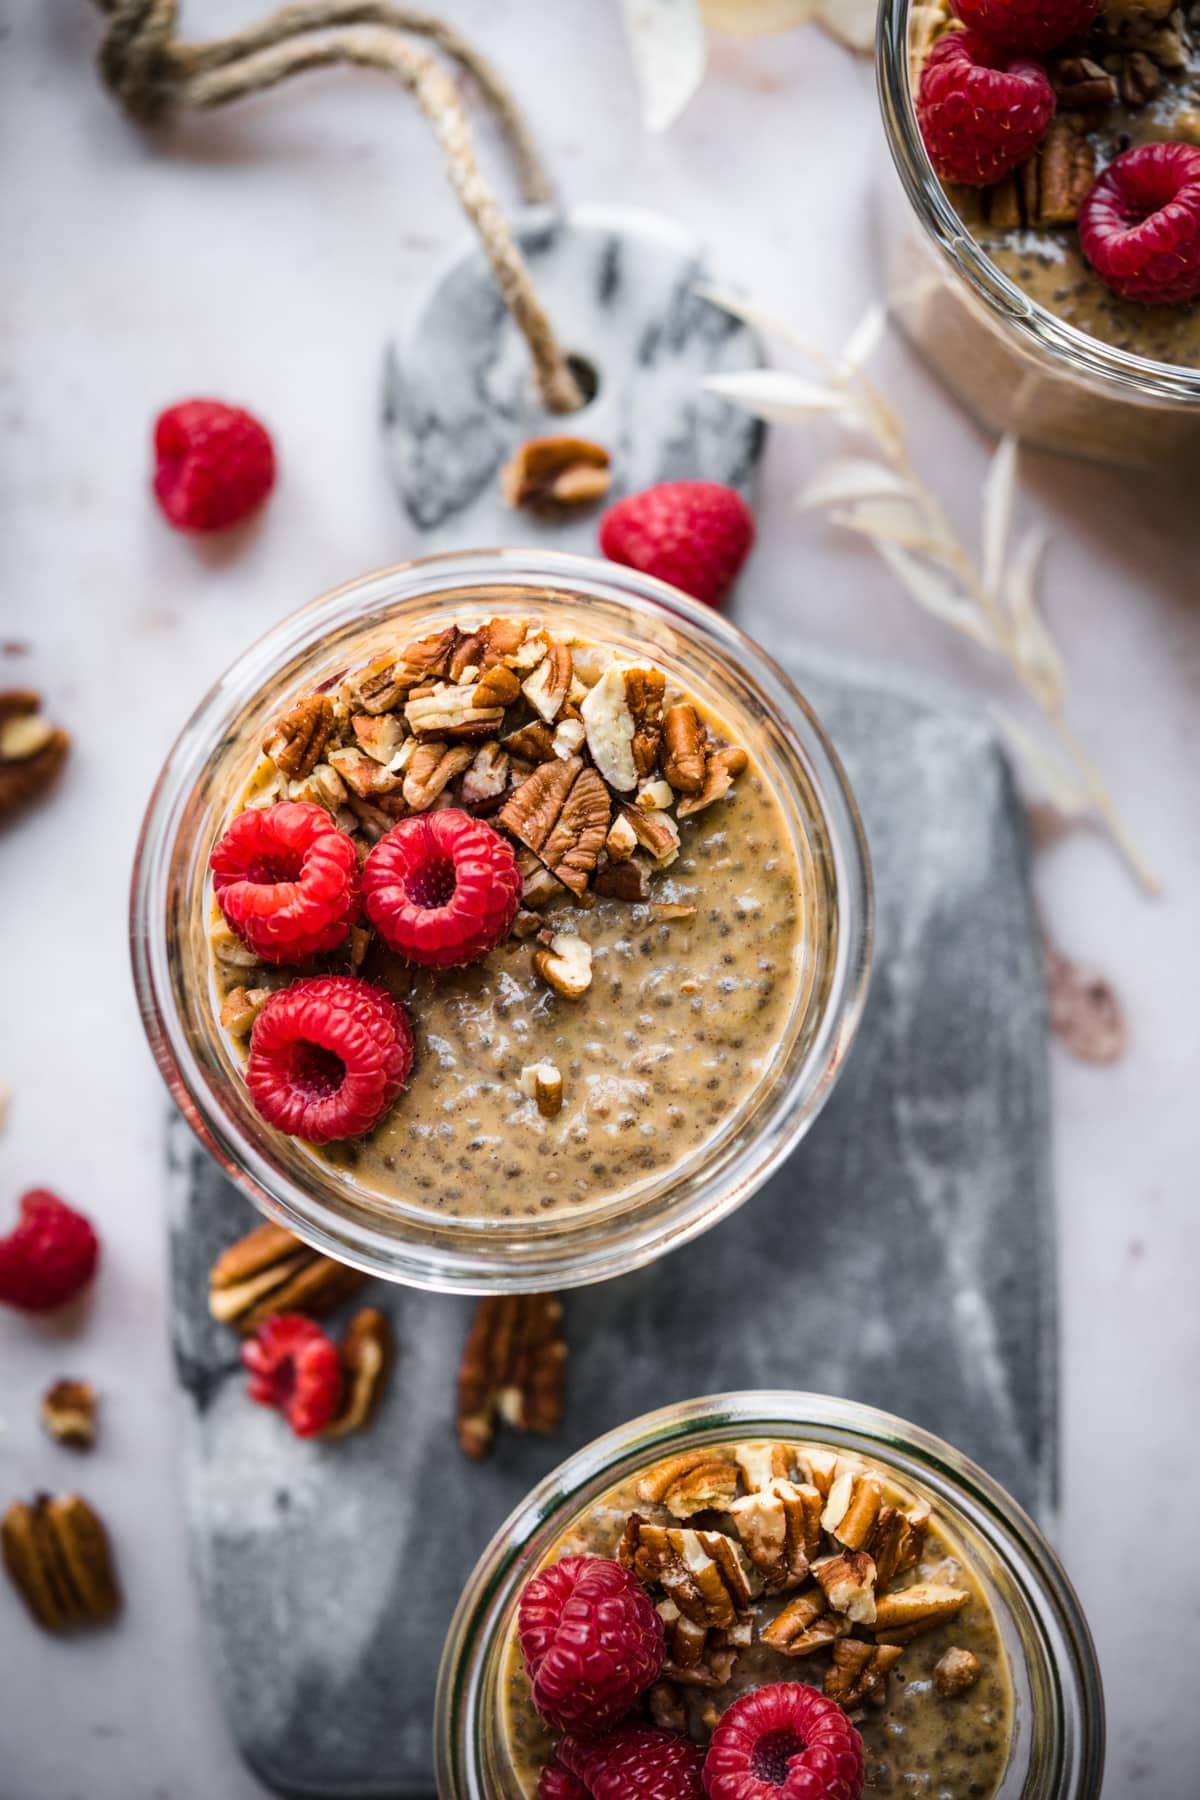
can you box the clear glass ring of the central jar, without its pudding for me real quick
[131,551,871,1292]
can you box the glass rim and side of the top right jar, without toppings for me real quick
[876,0,1200,468]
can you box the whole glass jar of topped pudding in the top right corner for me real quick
[878,0,1200,470]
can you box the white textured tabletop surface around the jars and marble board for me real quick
[0,0,1200,1800]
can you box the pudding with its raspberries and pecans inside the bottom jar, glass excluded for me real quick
[500,1440,1013,1800]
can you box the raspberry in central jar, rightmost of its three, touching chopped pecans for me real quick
[362,806,522,968]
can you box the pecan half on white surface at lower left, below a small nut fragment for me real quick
[0,1494,121,1631]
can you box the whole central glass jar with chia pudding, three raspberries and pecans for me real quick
[133,553,871,1292]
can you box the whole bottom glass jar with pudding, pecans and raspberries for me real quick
[435,1393,1103,1800]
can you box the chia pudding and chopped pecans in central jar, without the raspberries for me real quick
[209,616,805,1220]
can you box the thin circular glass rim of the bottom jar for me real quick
[434,1388,1105,1800]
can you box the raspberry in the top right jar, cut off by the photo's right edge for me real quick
[1079,144,1200,306]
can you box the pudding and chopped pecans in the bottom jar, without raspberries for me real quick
[500,1442,1015,1800]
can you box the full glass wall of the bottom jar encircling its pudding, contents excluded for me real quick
[434,1391,1105,1800]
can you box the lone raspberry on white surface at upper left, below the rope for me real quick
[155,400,275,531]
